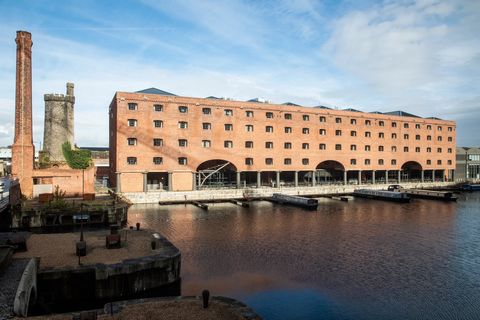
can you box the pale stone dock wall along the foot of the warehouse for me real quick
[122,182,455,203]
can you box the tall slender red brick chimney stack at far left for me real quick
[12,31,35,197]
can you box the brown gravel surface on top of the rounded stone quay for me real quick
[14,230,153,269]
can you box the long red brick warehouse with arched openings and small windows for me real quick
[109,88,456,192]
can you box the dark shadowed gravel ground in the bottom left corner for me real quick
[0,259,30,319]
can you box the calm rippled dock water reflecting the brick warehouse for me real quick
[129,193,480,319]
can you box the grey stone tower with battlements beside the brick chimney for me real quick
[43,83,75,162]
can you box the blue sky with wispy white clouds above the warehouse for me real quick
[0,0,480,148]
